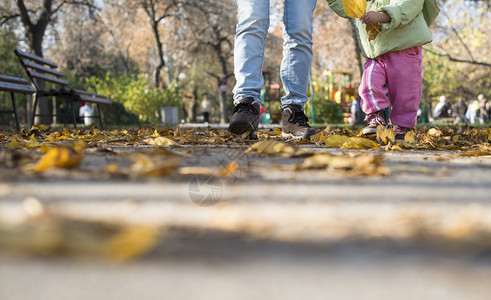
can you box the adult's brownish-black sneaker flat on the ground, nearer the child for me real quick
[281,104,315,140]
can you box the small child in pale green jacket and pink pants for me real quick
[327,0,439,139]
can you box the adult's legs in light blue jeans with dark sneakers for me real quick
[233,0,317,139]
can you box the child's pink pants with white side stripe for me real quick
[358,46,423,127]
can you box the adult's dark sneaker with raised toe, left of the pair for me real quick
[228,97,259,140]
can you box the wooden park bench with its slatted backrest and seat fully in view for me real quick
[15,49,112,127]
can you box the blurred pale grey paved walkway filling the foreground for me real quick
[0,145,491,300]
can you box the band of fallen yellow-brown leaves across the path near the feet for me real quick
[0,126,491,179]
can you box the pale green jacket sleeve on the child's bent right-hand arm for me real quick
[380,0,425,30]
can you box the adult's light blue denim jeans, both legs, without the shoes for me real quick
[234,0,317,108]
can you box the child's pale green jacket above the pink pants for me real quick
[327,0,438,58]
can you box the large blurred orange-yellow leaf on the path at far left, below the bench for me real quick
[34,147,85,172]
